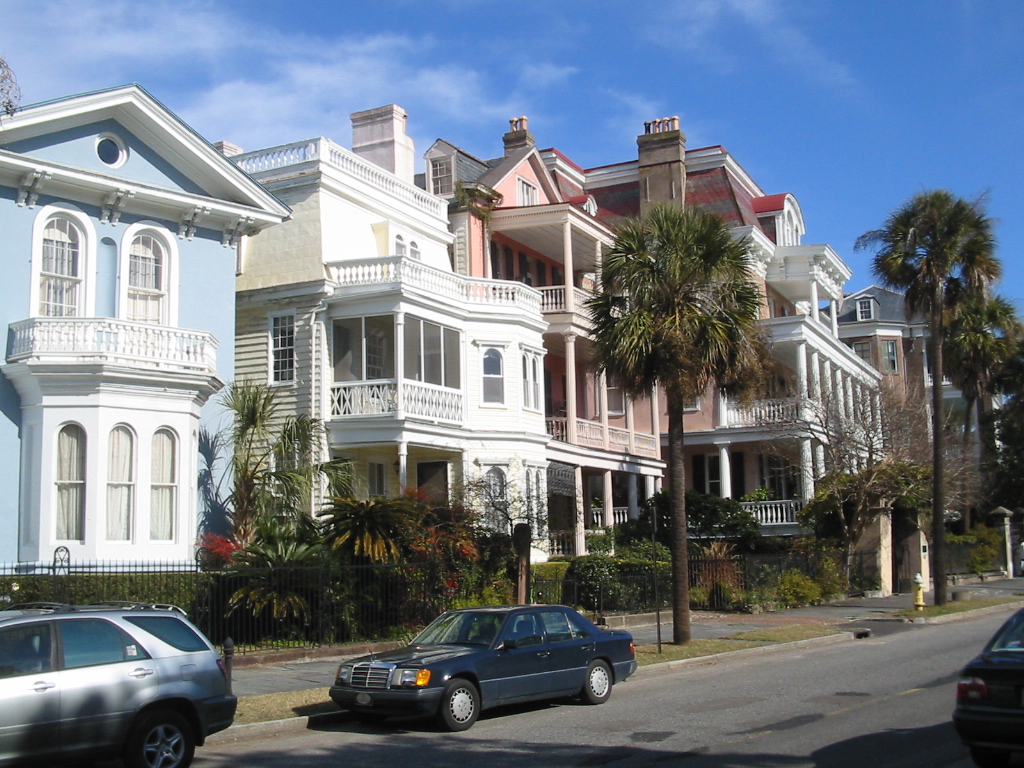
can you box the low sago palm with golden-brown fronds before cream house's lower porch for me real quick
[321,497,420,562]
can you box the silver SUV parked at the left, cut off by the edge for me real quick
[0,603,237,768]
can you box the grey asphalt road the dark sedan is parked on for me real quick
[196,610,1024,768]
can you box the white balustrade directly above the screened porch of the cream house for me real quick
[326,256,541,312]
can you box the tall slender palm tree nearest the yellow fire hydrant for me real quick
[856,189,1000,605]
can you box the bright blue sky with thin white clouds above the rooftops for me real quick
[0,0,1024,303]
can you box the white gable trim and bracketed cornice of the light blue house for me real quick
[0,84,291,230]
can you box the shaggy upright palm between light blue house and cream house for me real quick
[222,381,352,545]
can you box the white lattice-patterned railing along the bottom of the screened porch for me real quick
[331,379,465,423]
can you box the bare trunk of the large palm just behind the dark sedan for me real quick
[666,388,690,645]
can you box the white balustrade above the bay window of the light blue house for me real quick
[7,317,217,373]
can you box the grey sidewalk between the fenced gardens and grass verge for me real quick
[231,579,1024,696]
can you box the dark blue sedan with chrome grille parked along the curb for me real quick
[331,605,637,731]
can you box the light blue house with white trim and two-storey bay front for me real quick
[0,85,289,562]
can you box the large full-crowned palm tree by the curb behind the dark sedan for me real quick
[588,206,761,644]
